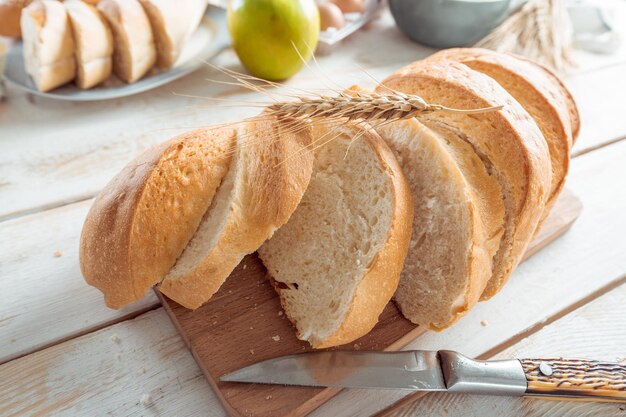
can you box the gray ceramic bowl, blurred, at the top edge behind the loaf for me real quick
[389,0,511,48]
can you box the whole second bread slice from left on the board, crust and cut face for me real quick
[159,117,313,308]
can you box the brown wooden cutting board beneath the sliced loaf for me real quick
[157,190,582,417]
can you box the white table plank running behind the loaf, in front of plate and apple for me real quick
[0,8,626,220]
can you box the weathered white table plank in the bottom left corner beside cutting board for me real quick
[0,308,225,417]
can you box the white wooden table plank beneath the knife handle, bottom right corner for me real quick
[383,285,626,417]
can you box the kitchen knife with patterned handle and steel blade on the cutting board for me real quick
[221,350,626,402]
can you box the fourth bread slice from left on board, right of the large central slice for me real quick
[376,119,504,330]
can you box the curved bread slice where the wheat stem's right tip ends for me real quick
[378,60,552,299]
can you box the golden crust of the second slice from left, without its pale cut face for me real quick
[159,117,313,309]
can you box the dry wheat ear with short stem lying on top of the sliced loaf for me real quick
[267,91,502,122]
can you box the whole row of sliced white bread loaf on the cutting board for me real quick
[81,48,580,348]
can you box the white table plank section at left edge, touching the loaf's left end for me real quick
[0,201,158,364]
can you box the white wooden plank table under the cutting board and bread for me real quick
[0,9,626,416]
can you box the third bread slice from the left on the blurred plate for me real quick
[98,0,156,83]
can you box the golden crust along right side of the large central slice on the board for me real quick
[306,122,413,349]
